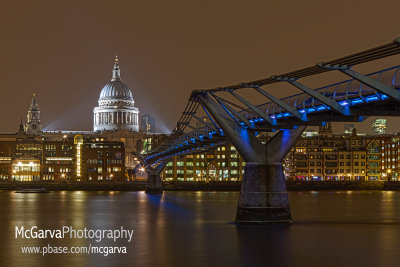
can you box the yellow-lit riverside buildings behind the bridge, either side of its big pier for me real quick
[162,123,400,181]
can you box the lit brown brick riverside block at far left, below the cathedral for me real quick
[0,134,129,181]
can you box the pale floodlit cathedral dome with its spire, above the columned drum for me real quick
[99,57,133,101]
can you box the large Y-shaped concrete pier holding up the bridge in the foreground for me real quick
[197,93,305,224]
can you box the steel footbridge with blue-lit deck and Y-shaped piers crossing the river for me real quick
[136,38,400,224]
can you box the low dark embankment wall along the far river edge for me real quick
[0,181,400,191]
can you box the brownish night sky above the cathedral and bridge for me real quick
[0,0,400,132]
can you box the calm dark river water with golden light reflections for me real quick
[0,191,400,267]
